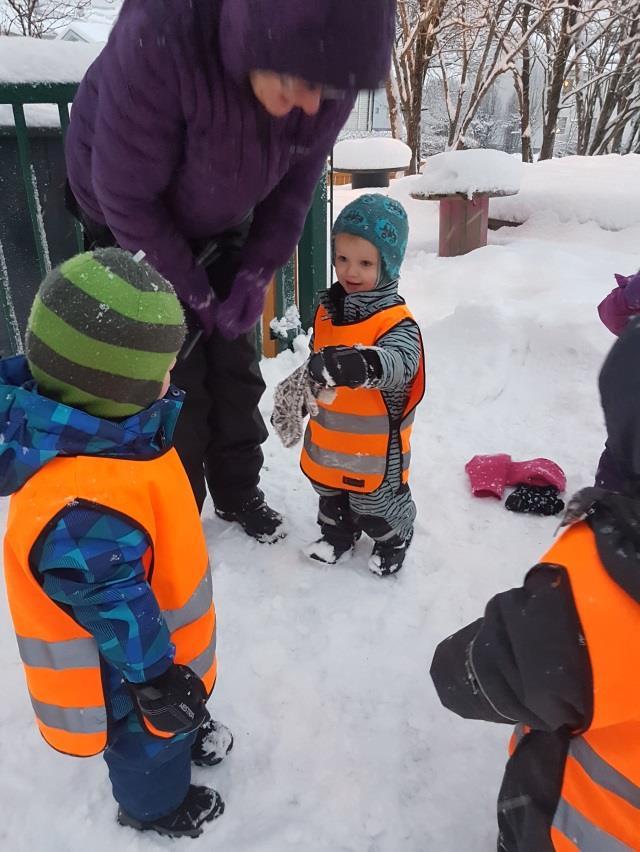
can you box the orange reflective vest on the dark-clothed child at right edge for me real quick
[512,522,640,852]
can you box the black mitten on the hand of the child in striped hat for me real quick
[128,664,207,737]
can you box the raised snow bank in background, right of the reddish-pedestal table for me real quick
[489,154,640,231]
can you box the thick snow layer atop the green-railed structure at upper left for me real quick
[0,36,103,84]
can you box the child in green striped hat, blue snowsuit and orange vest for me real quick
[0,248,233,837]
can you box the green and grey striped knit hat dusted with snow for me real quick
[25,248,185,419]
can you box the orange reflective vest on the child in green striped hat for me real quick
[4,449,216,757]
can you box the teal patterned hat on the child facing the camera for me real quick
[331,194,409,281]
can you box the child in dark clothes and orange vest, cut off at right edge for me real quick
[431,319,640,852]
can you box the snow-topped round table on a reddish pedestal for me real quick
[411,150,522,257]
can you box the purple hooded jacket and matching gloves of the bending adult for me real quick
[66,0,395,332]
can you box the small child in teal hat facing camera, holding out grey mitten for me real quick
[272,194,425,576]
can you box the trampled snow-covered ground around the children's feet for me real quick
[0,163,640,852]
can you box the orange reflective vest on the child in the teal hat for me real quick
[300,305,425,494]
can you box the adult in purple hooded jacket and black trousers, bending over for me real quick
[66,0,395,541]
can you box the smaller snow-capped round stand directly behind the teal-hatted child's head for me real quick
[333,136,411,189]
